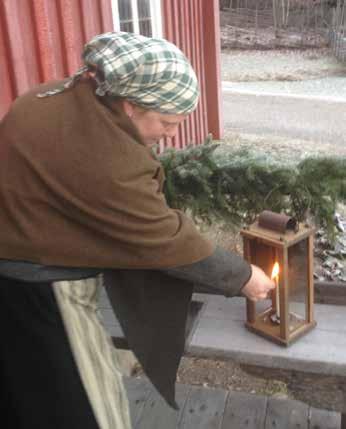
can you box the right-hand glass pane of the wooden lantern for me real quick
[288,239,308,333]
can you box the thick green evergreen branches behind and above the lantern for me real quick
[160,138,346,237]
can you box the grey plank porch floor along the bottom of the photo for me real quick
[125,378,340,429]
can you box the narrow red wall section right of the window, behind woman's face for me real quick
[161,0,222,147]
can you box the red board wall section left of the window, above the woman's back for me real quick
[0,0,113,117]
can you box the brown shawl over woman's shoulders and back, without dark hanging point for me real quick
[0,81,213,269]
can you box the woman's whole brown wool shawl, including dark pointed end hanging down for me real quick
[0,82,214,408]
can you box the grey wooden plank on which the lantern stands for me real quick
[188,296,346,378]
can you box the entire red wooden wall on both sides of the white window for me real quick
[0,0,222,148]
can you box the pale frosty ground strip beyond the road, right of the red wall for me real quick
[221,48,346,102]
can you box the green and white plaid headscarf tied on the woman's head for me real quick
[39,32,199,114]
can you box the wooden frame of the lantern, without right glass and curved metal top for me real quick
[241,216,316,346]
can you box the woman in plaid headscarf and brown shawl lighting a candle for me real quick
[0,33,274,429]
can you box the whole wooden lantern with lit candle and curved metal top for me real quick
[241,210,316,346]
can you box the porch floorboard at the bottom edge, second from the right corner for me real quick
[265,398,309,429]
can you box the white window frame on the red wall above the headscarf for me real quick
[111,0,163,37]
